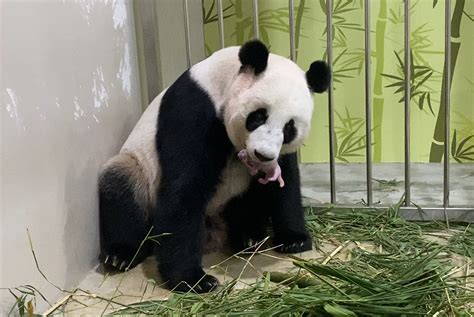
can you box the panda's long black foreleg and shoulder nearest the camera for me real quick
[153,72,233,292]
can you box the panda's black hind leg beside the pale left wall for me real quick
[99,154,153,271]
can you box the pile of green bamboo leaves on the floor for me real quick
[114,201,474,316]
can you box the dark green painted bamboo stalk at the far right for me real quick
[430,0,465,163]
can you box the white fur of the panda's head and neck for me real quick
[191,46,313,159]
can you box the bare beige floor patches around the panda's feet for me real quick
[52,247,338,316]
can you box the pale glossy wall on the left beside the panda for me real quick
[0,0,141,315]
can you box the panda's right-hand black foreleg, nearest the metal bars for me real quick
[261,153,312,253]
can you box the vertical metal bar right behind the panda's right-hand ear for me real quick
[326,0,336,204]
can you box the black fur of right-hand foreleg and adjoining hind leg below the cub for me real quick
[225,153,312,253]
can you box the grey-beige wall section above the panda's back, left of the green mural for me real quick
[134,0,205,106]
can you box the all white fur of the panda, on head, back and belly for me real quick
[106,47,313,214]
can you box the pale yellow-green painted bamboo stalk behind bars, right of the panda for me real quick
[372,0,387,162]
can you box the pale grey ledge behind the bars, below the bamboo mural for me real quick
[300,163,474,207]
